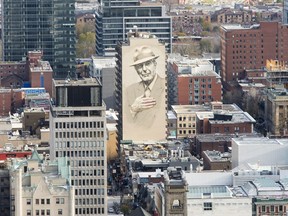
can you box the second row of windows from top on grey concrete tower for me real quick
[55,131,104,139]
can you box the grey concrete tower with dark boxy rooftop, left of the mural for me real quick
[50,78,107,215]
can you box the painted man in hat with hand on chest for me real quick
[126,46,165,128]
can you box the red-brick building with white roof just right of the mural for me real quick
[168,59,222,105]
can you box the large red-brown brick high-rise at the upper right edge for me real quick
[220,22,288,82]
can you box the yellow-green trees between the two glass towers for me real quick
[76,32,95,58]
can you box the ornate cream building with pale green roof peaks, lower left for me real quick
[10,151,74,216]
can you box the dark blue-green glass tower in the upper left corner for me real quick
[2,0,76,78]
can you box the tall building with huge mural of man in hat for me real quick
[116,33,167,141]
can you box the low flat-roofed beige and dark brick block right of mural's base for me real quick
[172,102,256,138]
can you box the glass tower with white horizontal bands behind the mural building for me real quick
[96,0,172,56]
